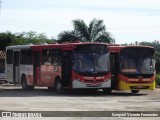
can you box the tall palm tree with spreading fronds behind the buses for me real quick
[58,19,115,43]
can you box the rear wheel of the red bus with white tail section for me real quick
[21,76,34,90]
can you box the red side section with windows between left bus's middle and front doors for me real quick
[37,49,61,87]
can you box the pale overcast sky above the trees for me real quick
[0,0,160,44]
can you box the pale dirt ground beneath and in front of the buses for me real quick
[0,86,160,120]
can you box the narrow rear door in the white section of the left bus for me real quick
[13,51,20,84]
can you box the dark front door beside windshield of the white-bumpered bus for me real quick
[62,51,72,87]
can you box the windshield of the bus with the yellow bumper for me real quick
[120,55,155,74]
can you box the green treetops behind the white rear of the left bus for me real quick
[0,31,54,50]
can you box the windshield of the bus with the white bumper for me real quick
[73,52,110,72]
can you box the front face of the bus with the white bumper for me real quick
[72,44,111,88]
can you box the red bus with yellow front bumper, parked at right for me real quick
[110,45,155,93]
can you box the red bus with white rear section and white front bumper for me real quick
[6,43,111,93]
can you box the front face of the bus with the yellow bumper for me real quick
[118,47,155,90]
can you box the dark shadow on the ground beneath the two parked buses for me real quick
[0,86,148,97]
